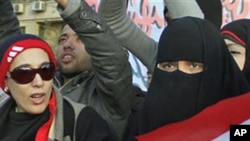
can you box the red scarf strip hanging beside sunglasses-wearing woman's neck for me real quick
[35,91,56,141]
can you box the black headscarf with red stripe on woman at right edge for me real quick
[221,19,250,85]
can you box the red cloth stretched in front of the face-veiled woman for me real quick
[136,93,250,141]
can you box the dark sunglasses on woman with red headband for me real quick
[7,63,55,84]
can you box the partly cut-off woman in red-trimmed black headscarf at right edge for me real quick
[221,19,250,84]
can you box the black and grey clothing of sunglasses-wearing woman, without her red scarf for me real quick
[0,91,113,141]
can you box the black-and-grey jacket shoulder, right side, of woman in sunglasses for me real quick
[63,94,113,140]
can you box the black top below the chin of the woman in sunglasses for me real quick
[0,99,50,141]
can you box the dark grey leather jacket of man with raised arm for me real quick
[54,1,132,141]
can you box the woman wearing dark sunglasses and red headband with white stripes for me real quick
[0,34,112,141]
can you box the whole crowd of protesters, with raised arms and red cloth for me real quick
[0,0,250,141]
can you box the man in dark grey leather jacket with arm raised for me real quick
[54,0,133,141]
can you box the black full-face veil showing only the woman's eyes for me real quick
[138,17,249,134]
